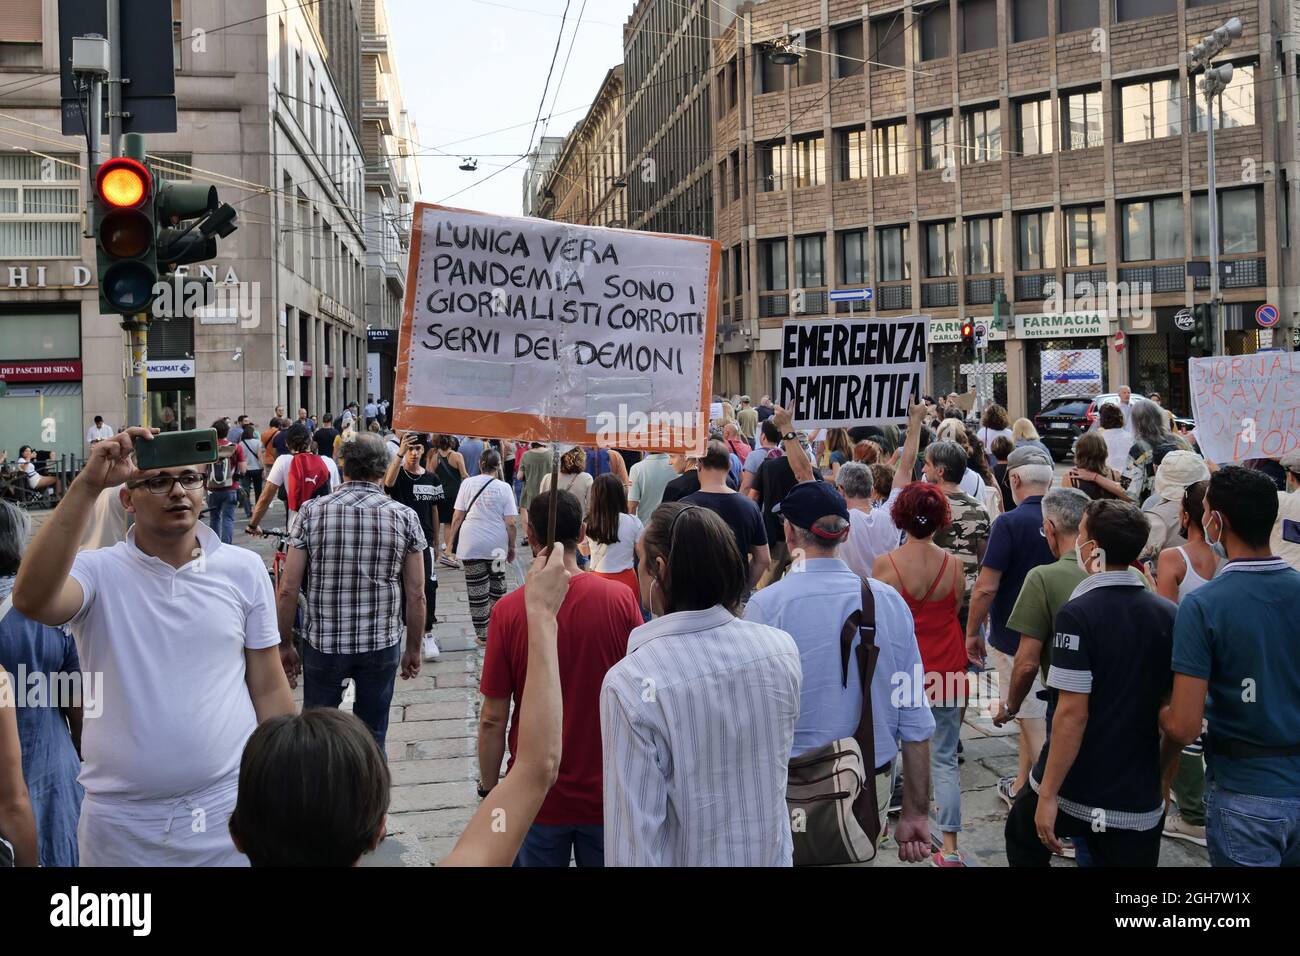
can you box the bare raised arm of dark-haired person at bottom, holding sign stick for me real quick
[443,545,569,866]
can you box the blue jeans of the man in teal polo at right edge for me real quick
[1205,780,1300,866]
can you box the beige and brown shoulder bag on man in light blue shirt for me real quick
[785,581,880,866]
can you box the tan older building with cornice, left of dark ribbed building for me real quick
[536,64,628,229]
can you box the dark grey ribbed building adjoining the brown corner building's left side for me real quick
[623,0,727,235]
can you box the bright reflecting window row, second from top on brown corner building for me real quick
[724,64,1255,195]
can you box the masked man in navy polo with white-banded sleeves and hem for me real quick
[1006,501,1182,866]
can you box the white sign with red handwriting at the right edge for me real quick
[1188,352,1300,464]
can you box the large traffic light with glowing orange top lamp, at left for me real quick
[94,156,159,315]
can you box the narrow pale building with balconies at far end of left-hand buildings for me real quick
[361,0,420,405]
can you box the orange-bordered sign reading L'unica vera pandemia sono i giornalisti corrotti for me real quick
[394,203,720,450]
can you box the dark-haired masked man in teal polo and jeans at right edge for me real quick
[1160,466,1300,866]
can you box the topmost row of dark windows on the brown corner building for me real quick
[728,0,1222,101]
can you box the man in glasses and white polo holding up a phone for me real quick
[13,428,294,866]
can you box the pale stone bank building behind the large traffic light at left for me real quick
[0,0,410,454]
